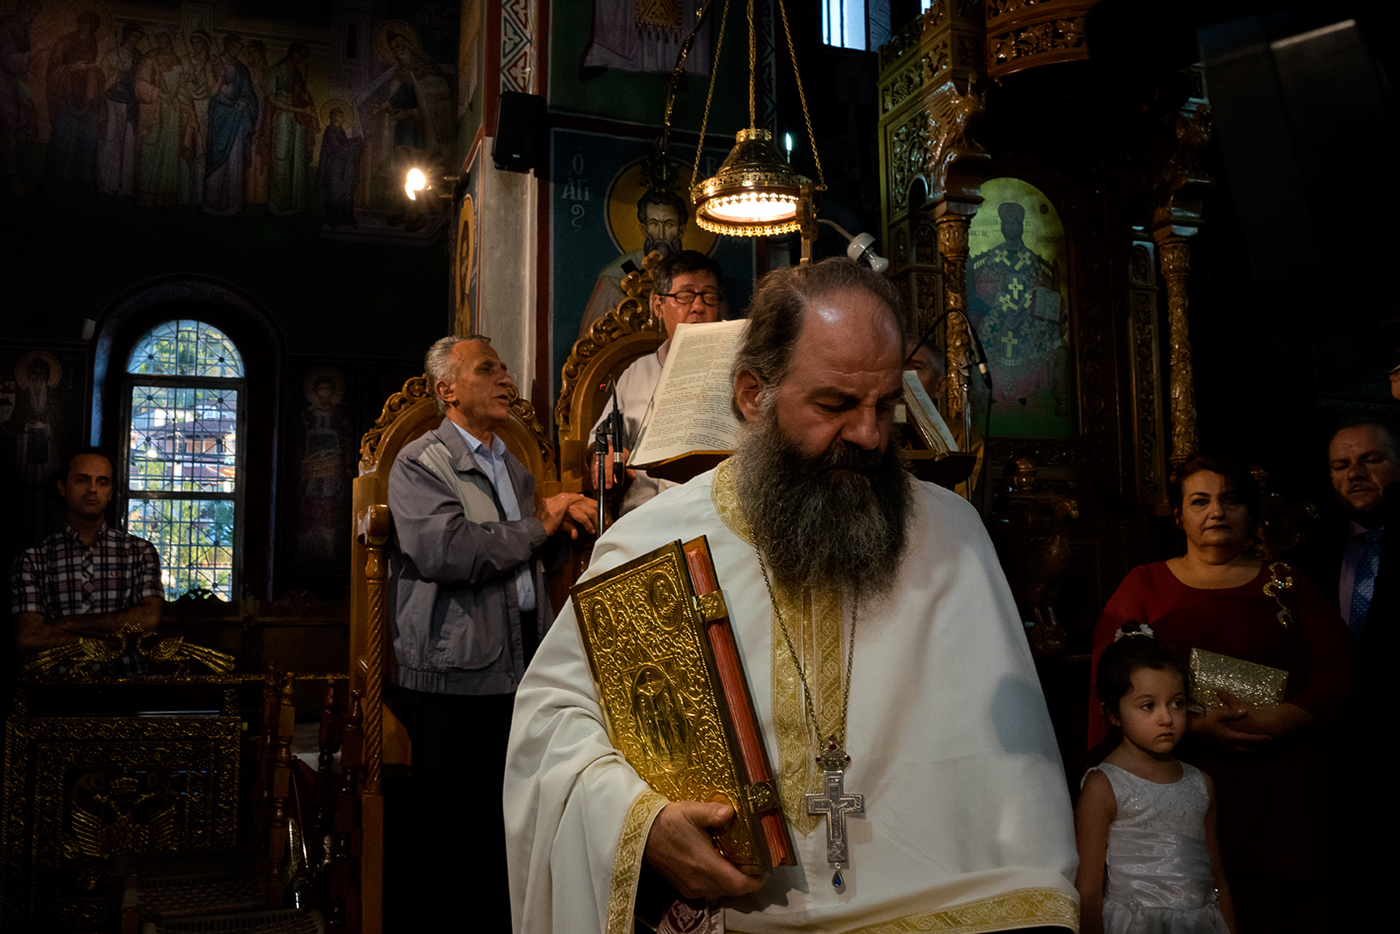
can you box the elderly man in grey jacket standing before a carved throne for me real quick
[389,336,596,931]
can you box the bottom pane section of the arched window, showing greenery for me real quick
[126,499,234,601]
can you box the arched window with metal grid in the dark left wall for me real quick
[123,319,245,601]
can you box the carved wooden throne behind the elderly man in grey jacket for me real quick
[349,377,559,934]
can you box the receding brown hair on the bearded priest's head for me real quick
[729,256,904,421]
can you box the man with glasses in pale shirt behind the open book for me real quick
[588,249,725,515]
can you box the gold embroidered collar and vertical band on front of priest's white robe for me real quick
[710,458,846,836]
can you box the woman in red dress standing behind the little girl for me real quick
[1089,455,1354,934]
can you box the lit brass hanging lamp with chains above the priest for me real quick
[677,0,826,263]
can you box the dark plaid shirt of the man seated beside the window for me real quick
[10,524,165,676]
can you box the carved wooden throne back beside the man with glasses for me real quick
[554,252,666,492]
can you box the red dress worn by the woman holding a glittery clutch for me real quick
[1089,562,1354,890]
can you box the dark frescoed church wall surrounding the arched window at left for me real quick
[0,0,473,669]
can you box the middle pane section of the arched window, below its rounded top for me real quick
[127,384,238,493]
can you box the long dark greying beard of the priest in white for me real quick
[735,396,913,598]
